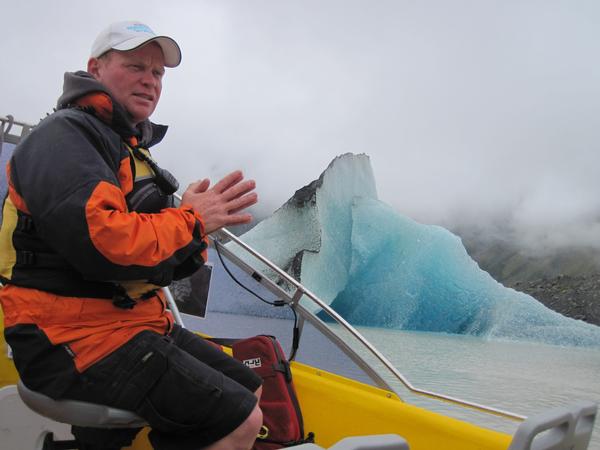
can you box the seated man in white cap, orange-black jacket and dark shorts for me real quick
[0,22,262,450]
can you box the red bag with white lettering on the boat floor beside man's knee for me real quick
[232,335,314,450]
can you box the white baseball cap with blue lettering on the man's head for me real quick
[90,21,181,67]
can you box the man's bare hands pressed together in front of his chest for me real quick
[181,170,258,233]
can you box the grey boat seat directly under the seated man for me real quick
[17,380,147,428]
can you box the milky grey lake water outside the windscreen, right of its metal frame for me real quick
[360,328,600,450]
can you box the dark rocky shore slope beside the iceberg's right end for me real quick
[509,273,600,326]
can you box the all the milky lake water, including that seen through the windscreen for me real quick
[184,312,600,450]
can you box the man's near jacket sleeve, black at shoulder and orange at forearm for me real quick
[9,109,207,285]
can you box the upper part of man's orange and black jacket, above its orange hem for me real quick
[0,72,206,307]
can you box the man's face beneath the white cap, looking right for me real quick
[88,43,165,125]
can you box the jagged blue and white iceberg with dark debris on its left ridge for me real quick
[224,154,600,346]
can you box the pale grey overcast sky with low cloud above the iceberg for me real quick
[0,0,600,247]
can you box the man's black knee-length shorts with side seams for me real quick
[64,326,262,450]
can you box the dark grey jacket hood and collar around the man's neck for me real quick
[56,70,168,147]
